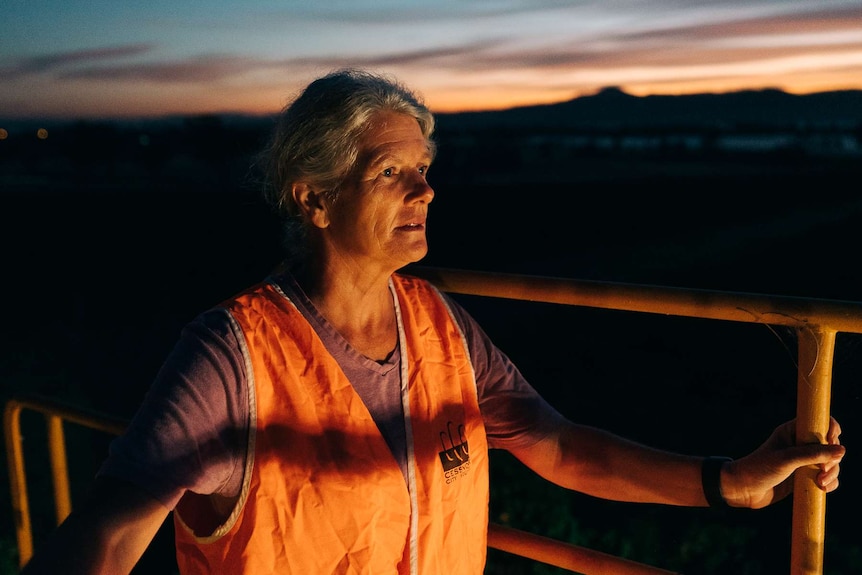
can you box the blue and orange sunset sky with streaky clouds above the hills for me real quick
[0,0,862,118]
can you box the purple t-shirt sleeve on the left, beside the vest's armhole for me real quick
[98,309,249,509]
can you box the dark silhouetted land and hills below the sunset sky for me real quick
[0,88,862,575]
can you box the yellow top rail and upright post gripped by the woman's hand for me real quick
[410,267,862,575]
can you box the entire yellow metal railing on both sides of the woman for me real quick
[4,267,862,575]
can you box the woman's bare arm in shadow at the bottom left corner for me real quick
[21,478,170,575]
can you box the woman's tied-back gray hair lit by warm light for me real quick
[265,68,434,218]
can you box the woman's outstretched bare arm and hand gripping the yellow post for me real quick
[513,419,844,508]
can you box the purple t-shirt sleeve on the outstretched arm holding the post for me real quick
[444,294,563,449]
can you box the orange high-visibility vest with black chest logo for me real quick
[174,274,488,575]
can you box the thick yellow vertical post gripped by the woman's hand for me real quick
[790,327,835,575]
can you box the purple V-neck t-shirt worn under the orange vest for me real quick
[99,274,561,509]
